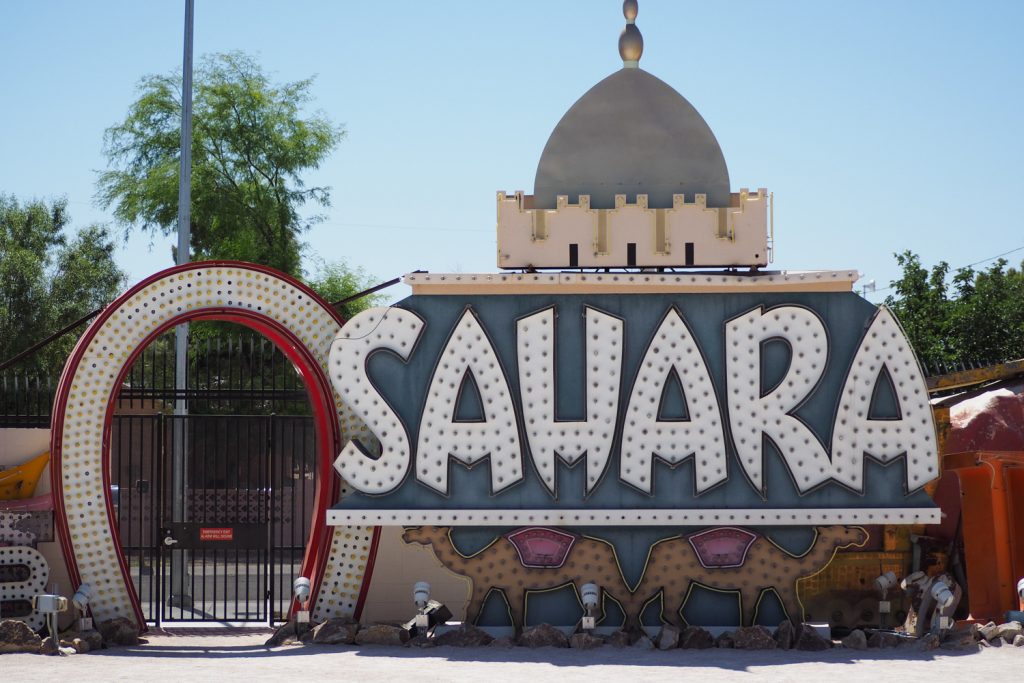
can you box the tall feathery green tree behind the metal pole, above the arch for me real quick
[96,52,344,275]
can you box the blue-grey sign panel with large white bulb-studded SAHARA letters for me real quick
[330,292,938,525]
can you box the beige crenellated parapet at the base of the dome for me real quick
[498,187,771,268]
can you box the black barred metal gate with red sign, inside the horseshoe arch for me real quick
[111,415,316,625]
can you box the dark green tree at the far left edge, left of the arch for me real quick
[0,195,125,374]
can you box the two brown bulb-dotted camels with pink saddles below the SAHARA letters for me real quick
[402,526,867,632]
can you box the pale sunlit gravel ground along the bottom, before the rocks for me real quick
[0,630,1024,683]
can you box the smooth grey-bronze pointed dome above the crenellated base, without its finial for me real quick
[534,69,729,209]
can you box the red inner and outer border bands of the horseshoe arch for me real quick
[50,261,368,629]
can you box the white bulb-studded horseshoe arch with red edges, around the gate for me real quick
[50,261,377,629]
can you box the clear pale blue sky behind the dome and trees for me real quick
[0,0,1024,301]
